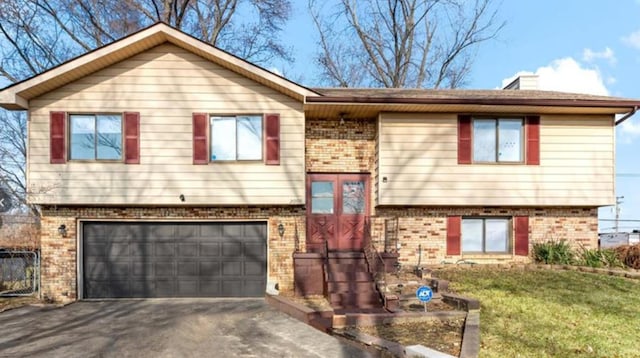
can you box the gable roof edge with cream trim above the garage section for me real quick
[0,22,318,109]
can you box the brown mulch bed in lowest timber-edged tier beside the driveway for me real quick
[354,318,464,357]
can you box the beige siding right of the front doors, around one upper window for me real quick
[377,113,615,206]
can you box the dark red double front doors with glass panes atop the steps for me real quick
[307,174,370,252]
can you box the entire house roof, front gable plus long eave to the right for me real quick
[0,23,640,118]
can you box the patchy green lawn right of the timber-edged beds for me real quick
[436,268,640,357]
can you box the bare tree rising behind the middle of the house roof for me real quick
[309,0,504,88]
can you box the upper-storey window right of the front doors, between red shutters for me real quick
[473,118,523,163]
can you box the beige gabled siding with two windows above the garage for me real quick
[28,44,305,205]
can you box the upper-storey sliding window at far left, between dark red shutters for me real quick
[69,114,122,160]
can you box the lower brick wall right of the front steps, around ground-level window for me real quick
[372,207,598,267]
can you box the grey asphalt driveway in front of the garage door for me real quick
[0,299,369,358]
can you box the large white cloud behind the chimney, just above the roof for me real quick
[502,57,609,96]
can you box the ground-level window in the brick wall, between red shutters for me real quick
[462,218,511,253]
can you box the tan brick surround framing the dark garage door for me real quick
[41,206,305,302]
